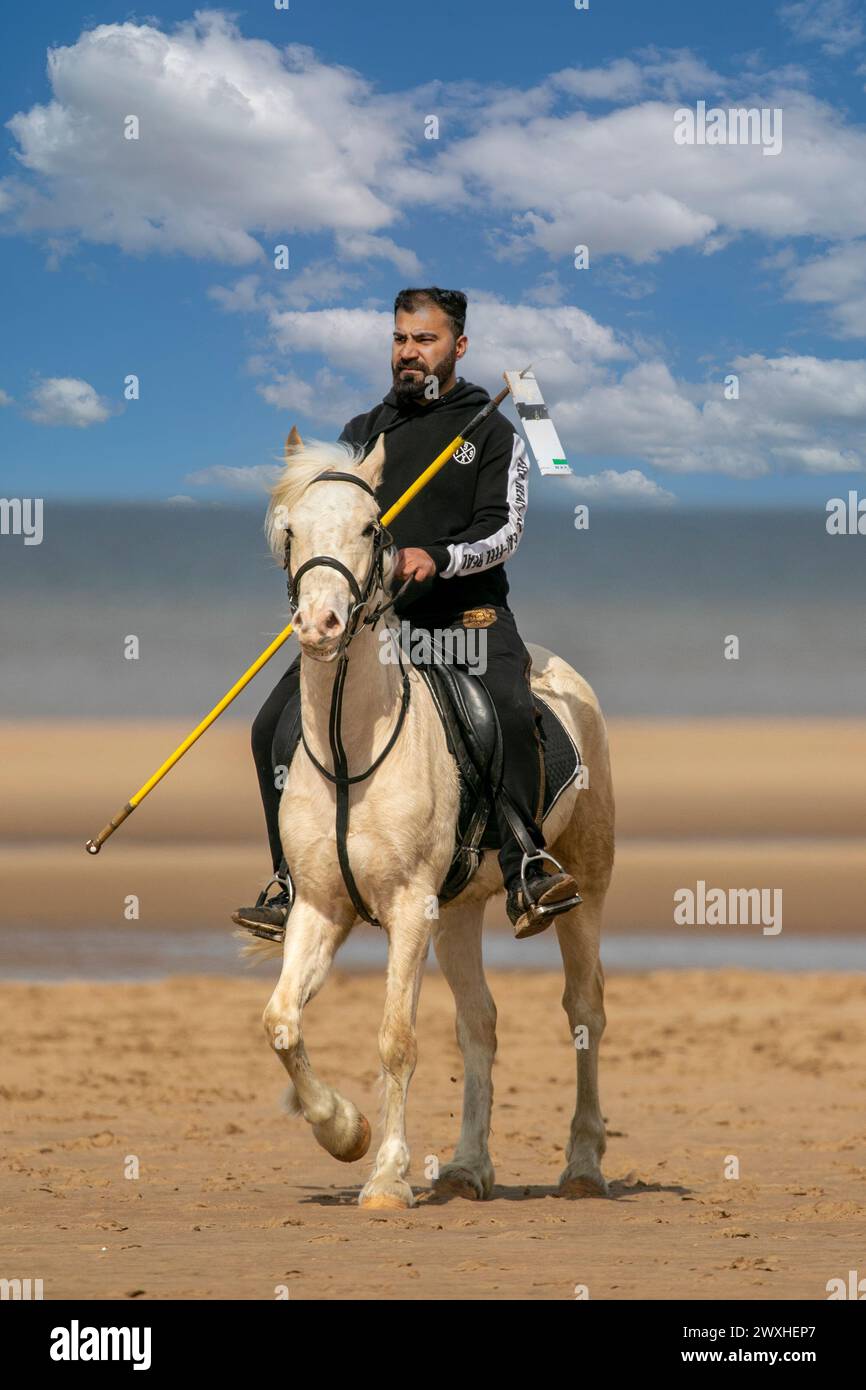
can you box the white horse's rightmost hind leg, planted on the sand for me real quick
[556,876,607,1197]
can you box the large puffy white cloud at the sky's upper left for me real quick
[0,11,422,264]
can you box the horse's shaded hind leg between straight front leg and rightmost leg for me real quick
[434,902,496,1200]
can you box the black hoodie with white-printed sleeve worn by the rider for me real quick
[341,377,530,627]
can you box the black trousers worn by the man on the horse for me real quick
[253,607,544,887]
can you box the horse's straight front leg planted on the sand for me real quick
[359,887,435,1209]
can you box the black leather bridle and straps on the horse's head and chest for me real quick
[285,470,411,927]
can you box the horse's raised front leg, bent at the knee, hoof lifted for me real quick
[263,902,370,1163]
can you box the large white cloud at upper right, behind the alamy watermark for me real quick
[439,89,866,261]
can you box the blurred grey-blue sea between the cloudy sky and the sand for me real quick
[0,503,866,720]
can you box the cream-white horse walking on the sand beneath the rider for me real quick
[257,436,613,1208]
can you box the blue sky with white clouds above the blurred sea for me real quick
[0,0,866,507]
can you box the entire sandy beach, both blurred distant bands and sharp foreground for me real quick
[0,720,866,1300]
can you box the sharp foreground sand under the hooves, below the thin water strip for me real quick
[0,972,866,1300]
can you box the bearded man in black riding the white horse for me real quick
[232,288,580,938]
